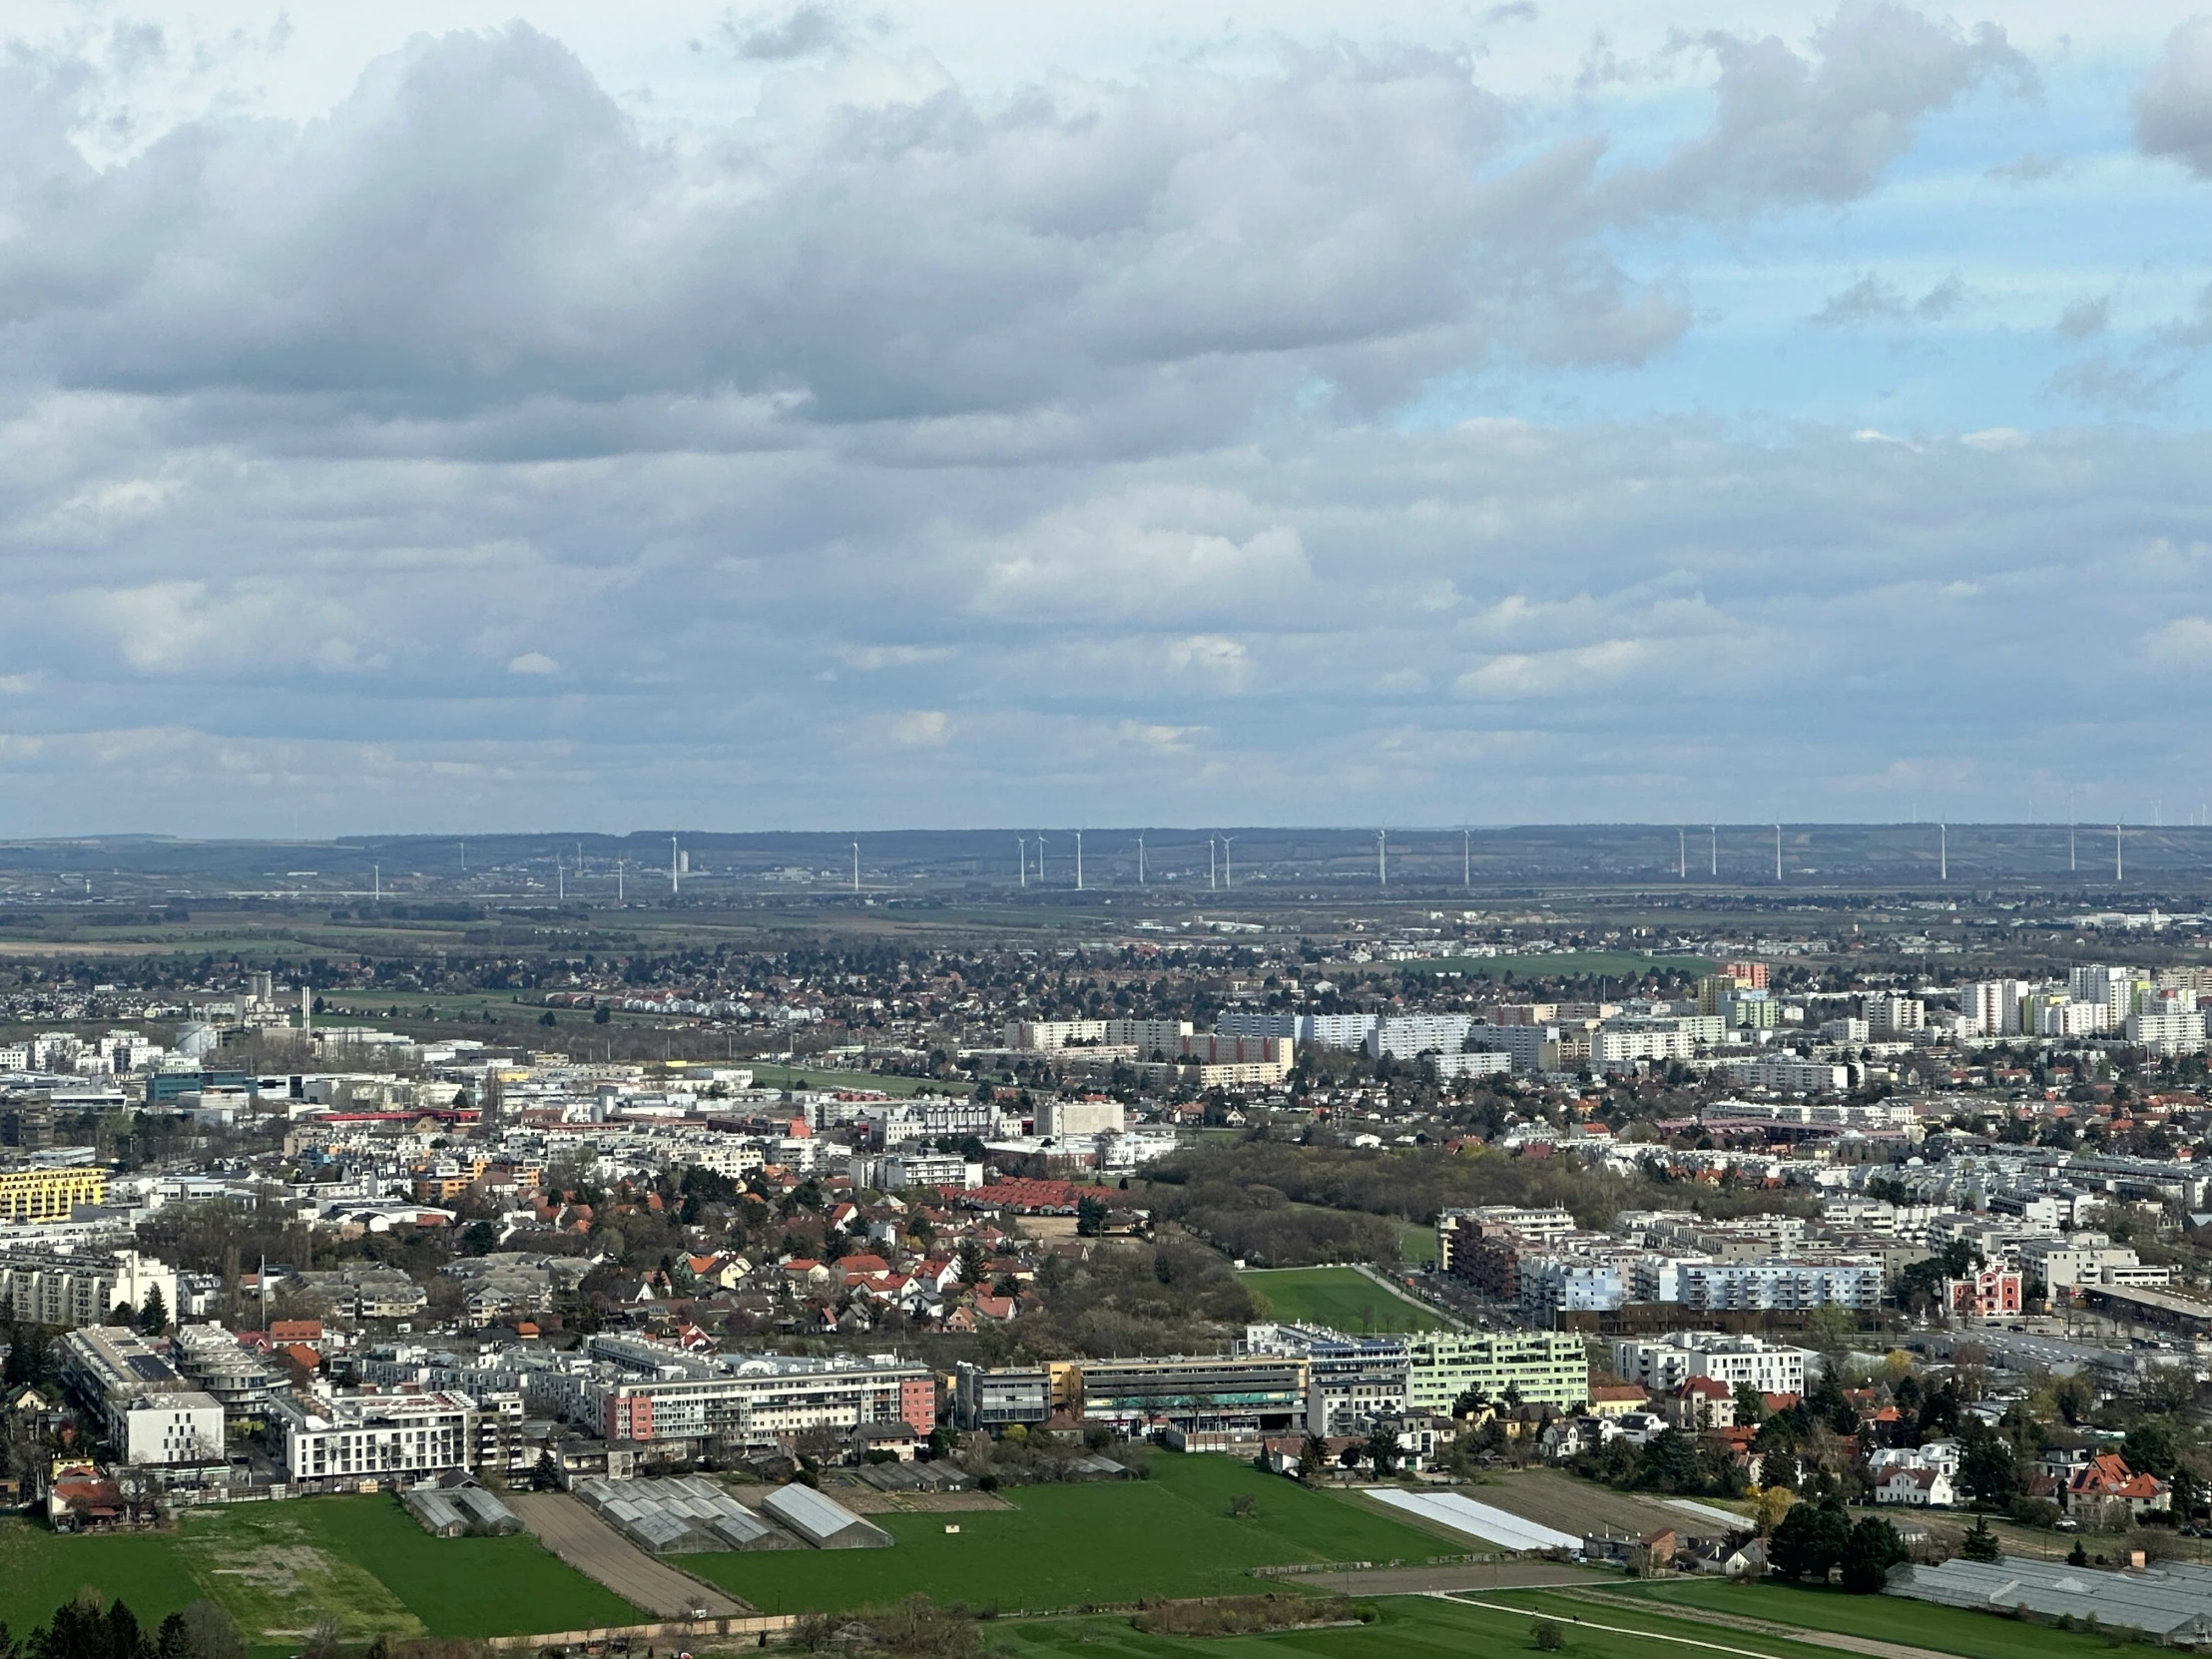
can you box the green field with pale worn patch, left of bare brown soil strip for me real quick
[0,1495,644,1652]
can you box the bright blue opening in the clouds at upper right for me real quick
[1398,64,2212,433]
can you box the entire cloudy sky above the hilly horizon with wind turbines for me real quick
[13,0,2212,836]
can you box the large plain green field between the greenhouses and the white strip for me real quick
[684,1455,1466,1612]
